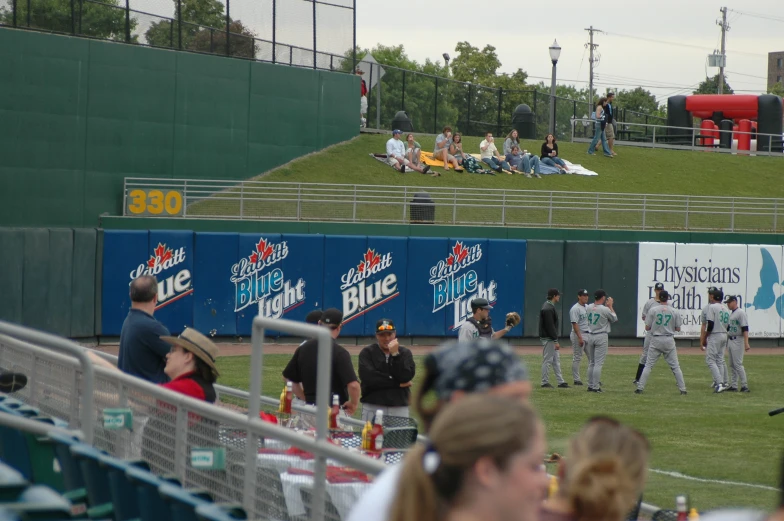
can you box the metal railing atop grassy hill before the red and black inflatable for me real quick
[571,118,784,157]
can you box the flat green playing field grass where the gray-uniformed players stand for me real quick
[218,355,784,510]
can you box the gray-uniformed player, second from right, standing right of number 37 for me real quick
[700,287,730,393]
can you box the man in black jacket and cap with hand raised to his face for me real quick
[359,318,416,421]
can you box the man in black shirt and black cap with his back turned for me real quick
[283,308,360,416]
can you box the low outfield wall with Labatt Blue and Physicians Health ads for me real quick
[0,223,784,345]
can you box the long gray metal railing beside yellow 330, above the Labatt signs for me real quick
[124,178,784,233]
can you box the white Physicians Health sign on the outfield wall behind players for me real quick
[635,243,784,337]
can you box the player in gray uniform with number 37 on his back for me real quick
[634,290,686,394]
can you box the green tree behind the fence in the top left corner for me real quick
[0,0,138,42]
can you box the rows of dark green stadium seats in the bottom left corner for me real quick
[0,395,247,521]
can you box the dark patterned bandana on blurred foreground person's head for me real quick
[425,338,528,400]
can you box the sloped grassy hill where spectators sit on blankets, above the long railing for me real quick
[255,134,784,197]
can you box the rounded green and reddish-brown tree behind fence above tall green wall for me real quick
[145,0,256,58]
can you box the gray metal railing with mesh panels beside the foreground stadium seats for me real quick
[0,318,386,521]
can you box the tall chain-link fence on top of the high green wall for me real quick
[0,0,356,70]
